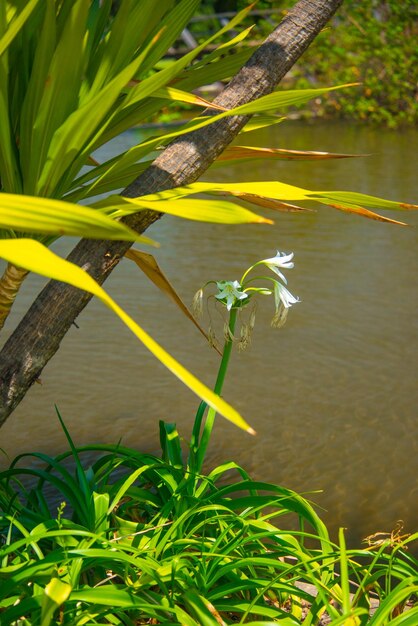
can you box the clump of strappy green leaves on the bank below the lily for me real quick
[0,408,418,626]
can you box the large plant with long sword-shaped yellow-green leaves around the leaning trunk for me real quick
[0,0,411,429]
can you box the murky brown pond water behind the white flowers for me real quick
[0,122,418,542]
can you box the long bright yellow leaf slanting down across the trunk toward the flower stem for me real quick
[0,239,254,434]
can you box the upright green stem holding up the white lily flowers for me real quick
[190,308,238,473]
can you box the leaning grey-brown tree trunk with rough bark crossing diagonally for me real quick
[0,0,343,424]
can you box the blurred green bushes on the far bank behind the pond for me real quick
[281,0,418,128]
